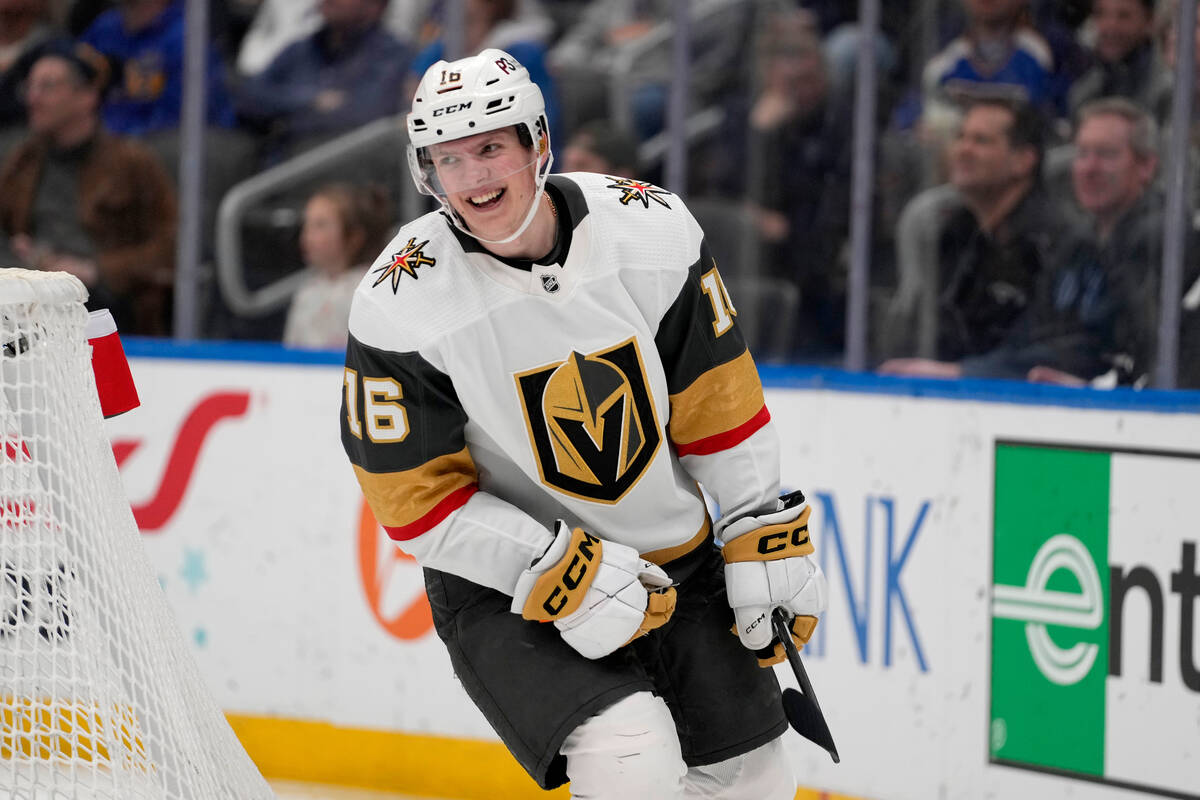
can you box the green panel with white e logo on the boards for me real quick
[991,445,1110,776]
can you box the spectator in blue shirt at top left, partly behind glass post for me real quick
[80,0,234,136]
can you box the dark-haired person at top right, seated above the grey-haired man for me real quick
[1069,0,1170,122]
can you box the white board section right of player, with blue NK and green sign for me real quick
[768,383,1200,800]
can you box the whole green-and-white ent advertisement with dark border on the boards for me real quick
[989,441,1200,800]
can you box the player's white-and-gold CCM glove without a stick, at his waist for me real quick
[511,521,676,658]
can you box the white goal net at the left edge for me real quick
[0,270,272,800]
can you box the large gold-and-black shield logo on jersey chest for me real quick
[516,338,662,503]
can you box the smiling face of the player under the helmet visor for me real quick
[428,127,538,240]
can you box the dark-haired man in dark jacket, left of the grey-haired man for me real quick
[881,100,1098,378]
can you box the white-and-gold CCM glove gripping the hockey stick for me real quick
[721,492,829,667]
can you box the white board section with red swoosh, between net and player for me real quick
[108,359,491,736]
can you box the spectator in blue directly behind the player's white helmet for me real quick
[404,0,552,149]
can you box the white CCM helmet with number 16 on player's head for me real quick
[408,48,553,245]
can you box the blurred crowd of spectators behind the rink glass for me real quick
[0,0,1200,387]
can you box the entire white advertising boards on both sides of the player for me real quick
[108,357,1200,800]
